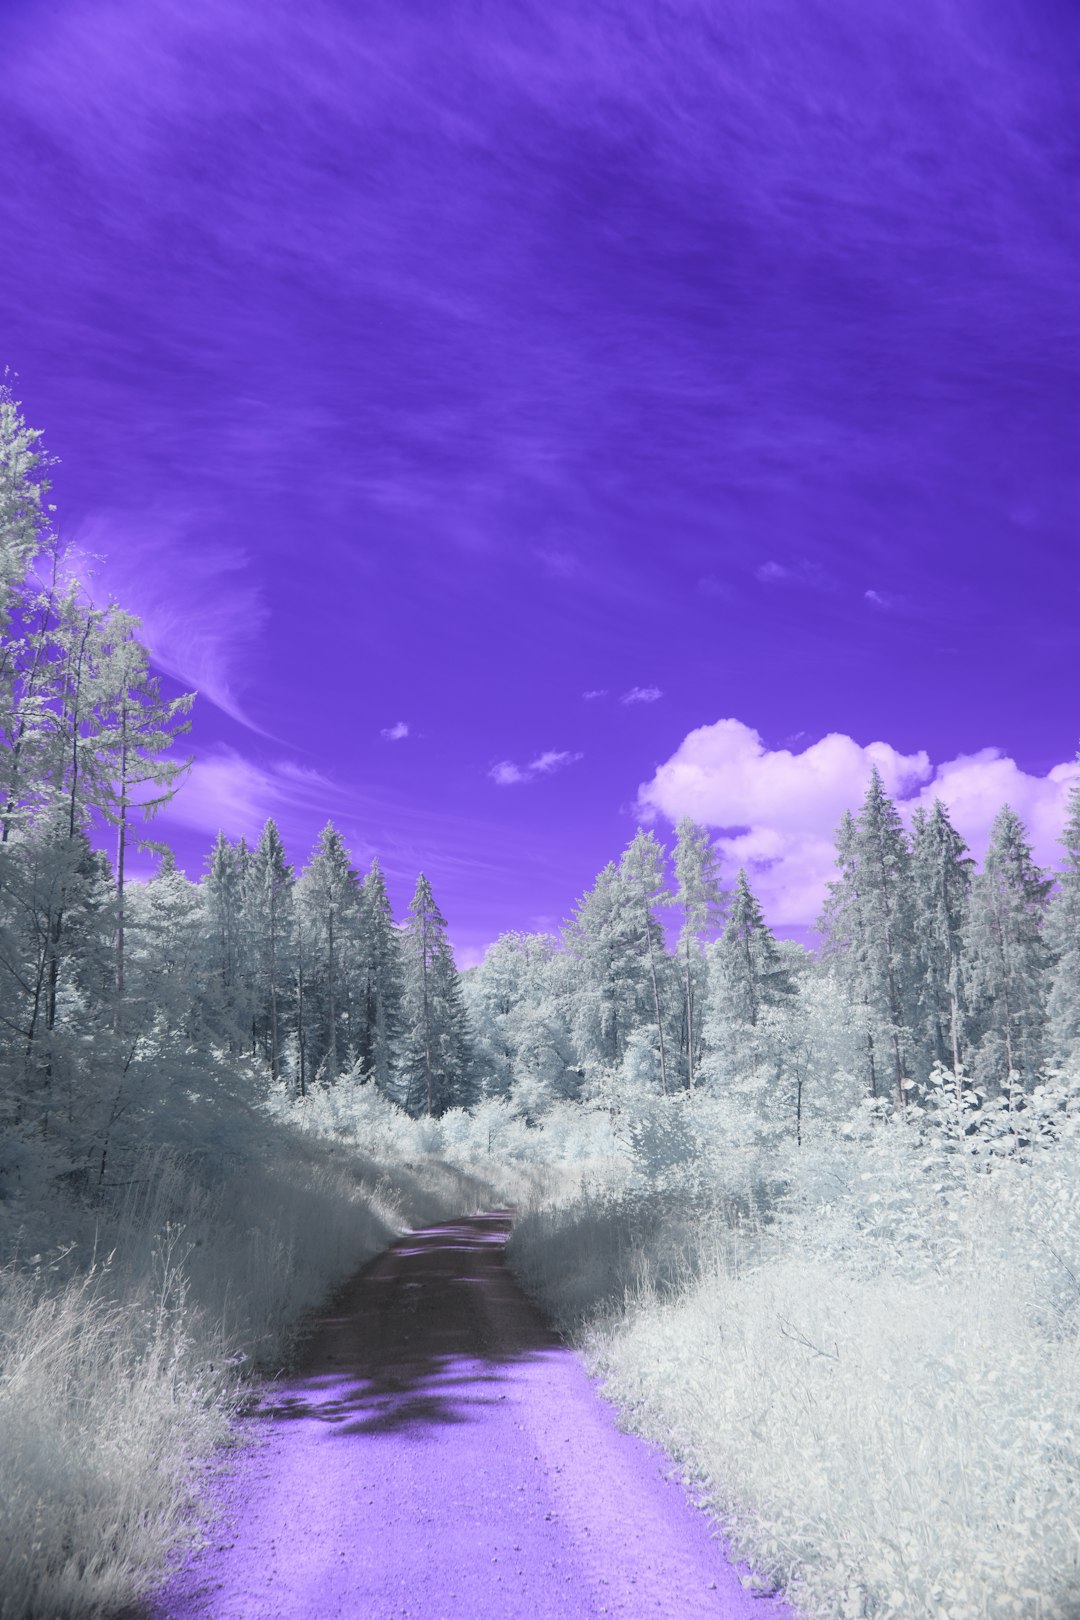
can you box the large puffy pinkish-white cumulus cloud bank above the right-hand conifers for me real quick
[638,719,1078,927]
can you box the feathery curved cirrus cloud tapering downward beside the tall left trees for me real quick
[70,505,267,735]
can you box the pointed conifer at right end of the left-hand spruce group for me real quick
[397,872,473,1115]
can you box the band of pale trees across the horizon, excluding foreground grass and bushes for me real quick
[0,379,1080,1218]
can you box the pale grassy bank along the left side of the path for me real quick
[0,1123,492,1620]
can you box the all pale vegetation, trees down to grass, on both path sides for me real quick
[0,390,1080,1620]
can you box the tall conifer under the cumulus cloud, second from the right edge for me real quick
[963,805,1052,1100]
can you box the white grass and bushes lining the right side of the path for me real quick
[512,1074,1080,1620]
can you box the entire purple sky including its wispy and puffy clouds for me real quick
[0,0,1080,962]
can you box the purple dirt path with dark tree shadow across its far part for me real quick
[149,1213,793,1620]
